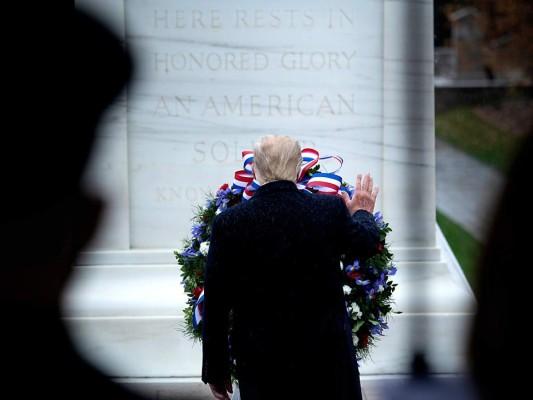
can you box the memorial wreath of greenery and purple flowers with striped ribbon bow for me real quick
[174,148,401,372]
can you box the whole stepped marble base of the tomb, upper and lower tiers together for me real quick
[64,245,475,378]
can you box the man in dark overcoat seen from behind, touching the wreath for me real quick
[202,135,380,400]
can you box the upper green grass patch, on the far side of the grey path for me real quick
[435,106,520,172]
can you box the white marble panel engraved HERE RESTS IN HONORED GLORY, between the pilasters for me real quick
[125,0,383,248]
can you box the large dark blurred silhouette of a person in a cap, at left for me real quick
[0,7,148,399]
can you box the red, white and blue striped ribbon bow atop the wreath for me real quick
[231,148,352,201]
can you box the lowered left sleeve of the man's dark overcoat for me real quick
[202,214,232,383]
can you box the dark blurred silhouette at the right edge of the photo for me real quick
[469,132,533,400]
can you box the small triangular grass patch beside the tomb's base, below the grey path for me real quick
[437,210,484,296]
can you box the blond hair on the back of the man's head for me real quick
[252,135,302,184]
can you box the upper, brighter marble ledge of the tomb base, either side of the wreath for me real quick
[64,261,475,317]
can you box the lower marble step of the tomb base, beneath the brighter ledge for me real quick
[63,313,471,378]
